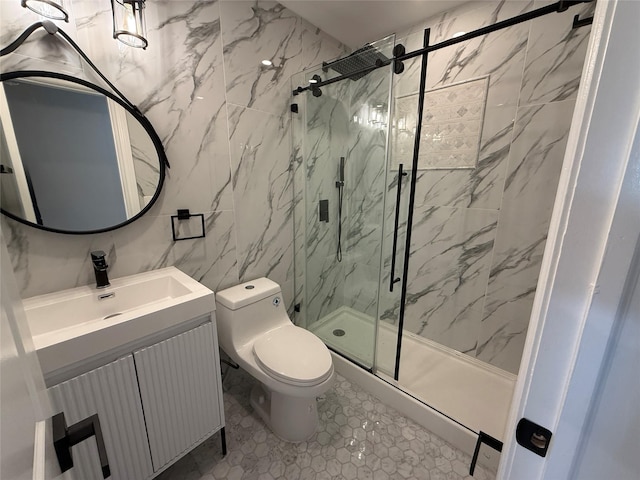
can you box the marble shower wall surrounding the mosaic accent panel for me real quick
[381,0,592,373]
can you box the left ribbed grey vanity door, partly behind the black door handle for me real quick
[49,355,153,480]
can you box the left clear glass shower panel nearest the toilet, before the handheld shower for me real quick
[292,36,399,370]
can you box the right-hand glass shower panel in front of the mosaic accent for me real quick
[376,0,588,440]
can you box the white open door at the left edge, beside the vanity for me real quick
[0,232,73,480]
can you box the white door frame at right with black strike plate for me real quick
[498,0,640,480]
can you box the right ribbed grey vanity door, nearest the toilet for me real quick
[133,323,222,471]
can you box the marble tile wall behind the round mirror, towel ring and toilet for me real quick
[0,0,343,303]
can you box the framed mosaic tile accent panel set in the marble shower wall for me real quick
[394,76,489,169]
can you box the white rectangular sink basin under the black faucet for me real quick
[23,267,215,375]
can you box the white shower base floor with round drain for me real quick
[310,307,516,440]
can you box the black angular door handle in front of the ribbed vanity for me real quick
[52,412,111,478]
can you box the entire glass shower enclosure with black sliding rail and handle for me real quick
[291,2,590,440]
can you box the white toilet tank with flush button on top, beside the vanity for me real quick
[216,277,291,352]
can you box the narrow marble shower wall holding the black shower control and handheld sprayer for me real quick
[293,79,349,326]
